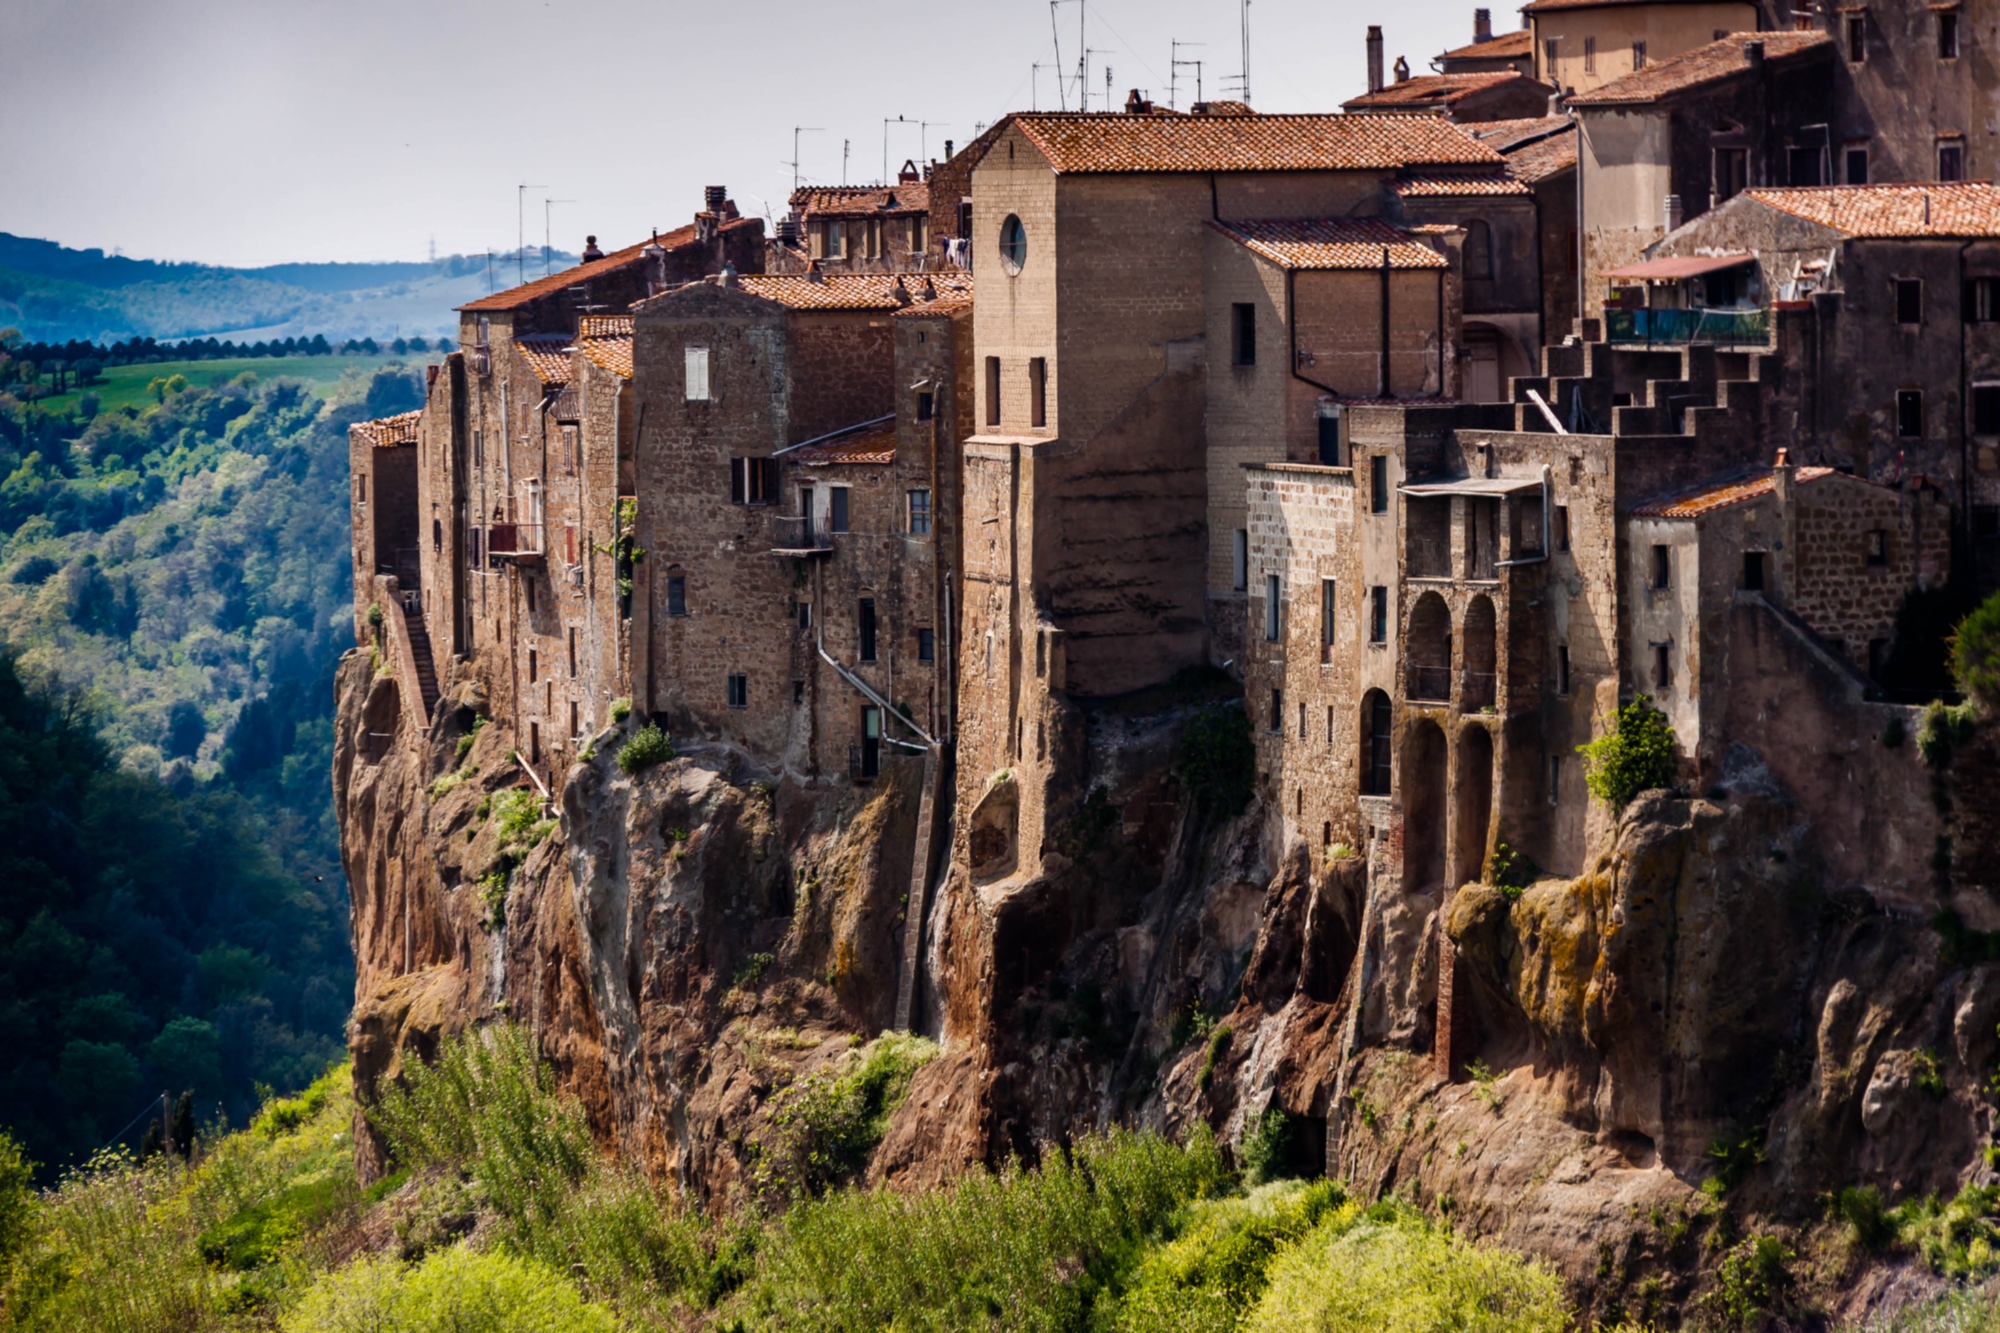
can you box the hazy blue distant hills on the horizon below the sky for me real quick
[0,232,576,342]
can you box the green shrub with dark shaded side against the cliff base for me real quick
[754,1020,938,1199]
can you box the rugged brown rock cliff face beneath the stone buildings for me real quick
[334,654,2000,1311]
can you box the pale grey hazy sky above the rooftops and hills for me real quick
[0,0,1520,264]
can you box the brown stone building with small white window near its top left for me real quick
[632,272,970,781]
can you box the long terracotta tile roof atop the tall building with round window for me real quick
[1012,112,1500,172]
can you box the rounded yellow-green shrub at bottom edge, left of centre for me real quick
[280,1245,616,1333]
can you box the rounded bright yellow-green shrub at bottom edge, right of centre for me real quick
[1242,1205,1570,1333]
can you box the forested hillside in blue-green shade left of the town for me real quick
[0,338,402,1165]
